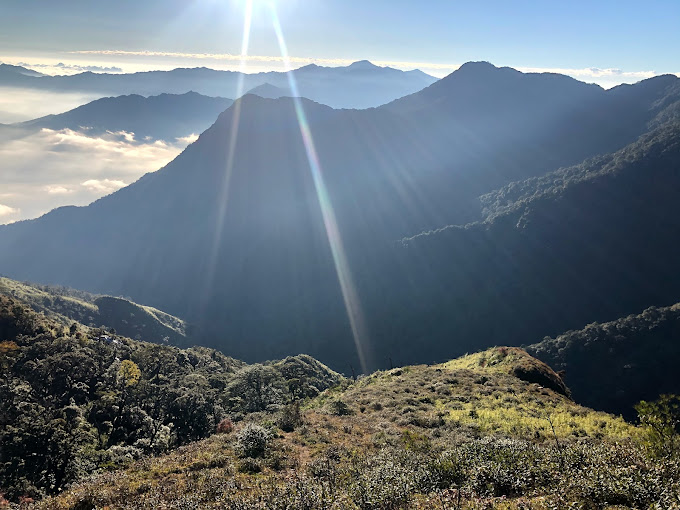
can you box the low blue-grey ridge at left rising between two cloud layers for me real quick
[8,92,233,141]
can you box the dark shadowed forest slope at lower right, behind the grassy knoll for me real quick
[527,304,680,417]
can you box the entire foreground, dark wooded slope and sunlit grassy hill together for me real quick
[0,297,680,510]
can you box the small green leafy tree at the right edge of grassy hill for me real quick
[635,395,680,457]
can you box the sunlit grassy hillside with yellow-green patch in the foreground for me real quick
[26,348,680,509]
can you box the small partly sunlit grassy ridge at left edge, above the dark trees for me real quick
[0,277,191,347]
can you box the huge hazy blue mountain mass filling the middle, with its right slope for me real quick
[0,63,680,370]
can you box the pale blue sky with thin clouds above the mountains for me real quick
[0,0,680,85]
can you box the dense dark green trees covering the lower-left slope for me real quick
[0,296,342,500]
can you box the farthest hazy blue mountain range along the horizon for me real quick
[0,61,437,108]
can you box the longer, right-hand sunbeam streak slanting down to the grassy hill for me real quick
[270,3,367,372]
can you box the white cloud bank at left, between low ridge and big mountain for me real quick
[0,129,195,223]
